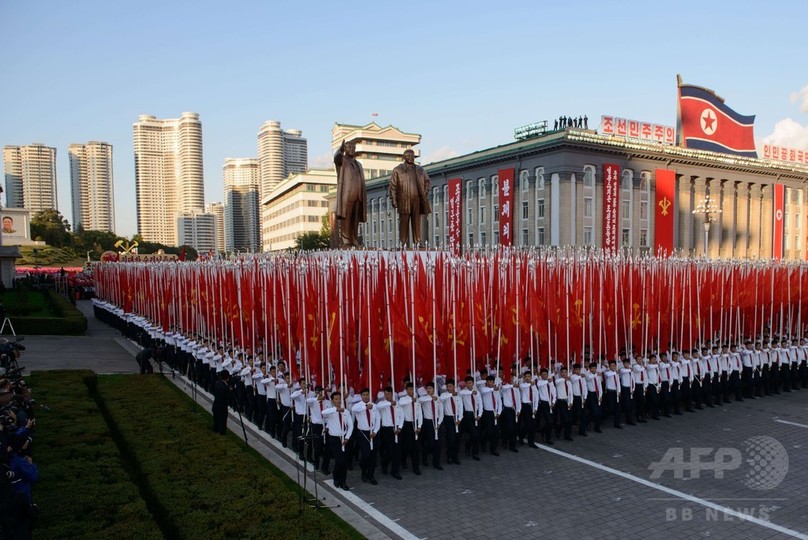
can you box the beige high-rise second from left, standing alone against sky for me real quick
[68,141,115,231]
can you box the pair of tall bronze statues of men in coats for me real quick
[334,141,432,247]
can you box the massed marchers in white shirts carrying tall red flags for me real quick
[94,248,808,489]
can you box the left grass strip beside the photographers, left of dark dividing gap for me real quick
[27,371,163,539]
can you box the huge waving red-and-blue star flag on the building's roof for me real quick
[678,84,757,158]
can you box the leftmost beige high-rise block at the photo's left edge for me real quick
[3,143,59,213]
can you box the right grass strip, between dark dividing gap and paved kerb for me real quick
[97,375,361,540]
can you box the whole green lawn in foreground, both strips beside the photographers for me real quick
[31,372,360,540]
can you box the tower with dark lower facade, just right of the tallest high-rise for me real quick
[222,158,261,251]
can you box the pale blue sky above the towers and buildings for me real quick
[0,0,808,236]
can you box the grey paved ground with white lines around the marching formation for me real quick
[17,304,808,540]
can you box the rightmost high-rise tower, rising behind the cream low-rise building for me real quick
[258,120,308,196]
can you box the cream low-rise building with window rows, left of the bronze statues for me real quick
[261,169,337,251]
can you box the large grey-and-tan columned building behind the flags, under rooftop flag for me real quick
[360,128,808,259]
